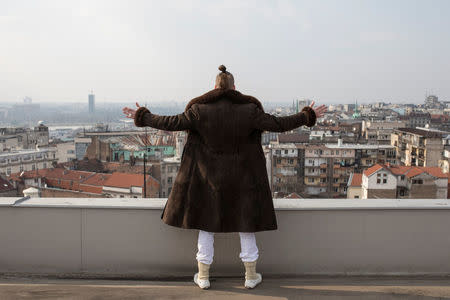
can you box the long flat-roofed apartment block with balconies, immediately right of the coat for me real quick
[265,140,396,197]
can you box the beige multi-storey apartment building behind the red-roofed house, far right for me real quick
[391,128,444,167]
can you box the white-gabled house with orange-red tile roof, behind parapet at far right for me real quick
[361,164,448,199]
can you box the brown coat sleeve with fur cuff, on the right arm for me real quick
[253,106,316,132]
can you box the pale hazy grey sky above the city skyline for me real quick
[0,0,450,103]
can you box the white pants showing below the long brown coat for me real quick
[197,230,259,265]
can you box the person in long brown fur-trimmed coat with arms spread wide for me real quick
[123,65,326,289]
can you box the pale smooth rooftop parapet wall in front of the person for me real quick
[0,198,450,278]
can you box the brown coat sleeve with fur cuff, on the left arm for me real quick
[134,106,198,131]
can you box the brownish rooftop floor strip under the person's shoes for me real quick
[0,275,450,300]
